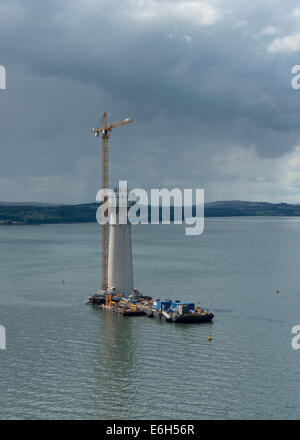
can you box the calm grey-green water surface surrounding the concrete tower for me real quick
[0,218,300,419]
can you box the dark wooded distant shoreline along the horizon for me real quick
[0,201,300,226]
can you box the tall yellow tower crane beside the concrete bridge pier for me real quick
[93,113,133,291]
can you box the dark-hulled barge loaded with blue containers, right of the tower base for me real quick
[147,299,214,323]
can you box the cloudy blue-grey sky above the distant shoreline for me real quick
[0,0,300,203]
